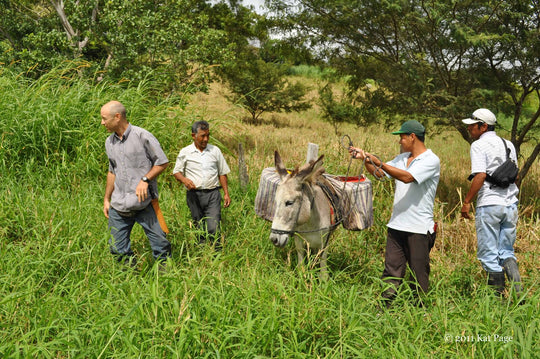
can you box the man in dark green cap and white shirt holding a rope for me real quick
[349,120,440,307]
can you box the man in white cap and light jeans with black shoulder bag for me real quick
[461,108,521,295]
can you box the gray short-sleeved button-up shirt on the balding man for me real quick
[105,124,169,212]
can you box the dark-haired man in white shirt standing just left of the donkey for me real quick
[173,121,231,250]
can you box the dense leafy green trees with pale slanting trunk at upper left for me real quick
[0,0,238,91]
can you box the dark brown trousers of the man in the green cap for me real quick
[382,228,436,299]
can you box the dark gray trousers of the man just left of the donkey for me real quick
[186,188,221,245]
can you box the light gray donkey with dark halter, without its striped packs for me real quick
[270,151,335,280]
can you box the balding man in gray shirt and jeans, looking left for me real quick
[101,101,171,265]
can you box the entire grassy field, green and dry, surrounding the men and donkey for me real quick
[0,68,540,358]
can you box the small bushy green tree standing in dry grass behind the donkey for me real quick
[220,58,311,122]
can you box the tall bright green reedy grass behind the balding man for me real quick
[0,62,187,177]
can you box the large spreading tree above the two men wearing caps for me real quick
[267,0,540,184]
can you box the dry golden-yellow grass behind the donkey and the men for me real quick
[186,84,540,291]
